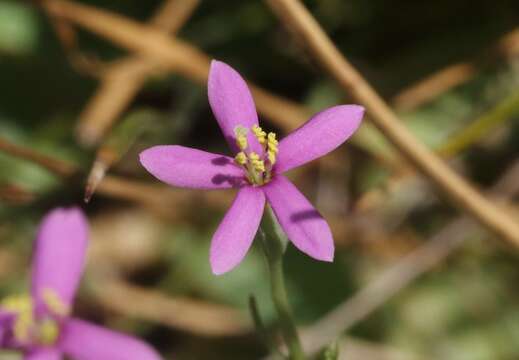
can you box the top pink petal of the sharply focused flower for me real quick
[207,60,263,154]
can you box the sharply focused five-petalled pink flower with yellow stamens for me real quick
[140,61,364,275]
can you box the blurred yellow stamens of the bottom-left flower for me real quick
[0,289,69,346]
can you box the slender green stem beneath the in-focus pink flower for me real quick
[260,207,306,360]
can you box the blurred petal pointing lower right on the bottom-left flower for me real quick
[59,319,161,360]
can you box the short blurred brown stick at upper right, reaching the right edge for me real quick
[392,29,519,111]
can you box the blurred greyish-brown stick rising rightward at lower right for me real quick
[302,161,519,352]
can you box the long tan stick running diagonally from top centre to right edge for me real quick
[267,0,519,246]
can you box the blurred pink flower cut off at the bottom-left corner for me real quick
[0,209,160,360]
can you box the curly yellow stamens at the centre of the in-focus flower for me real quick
[234,125,278,186]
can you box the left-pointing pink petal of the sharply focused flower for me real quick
[140,145,244,189]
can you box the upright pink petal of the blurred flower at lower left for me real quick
[31,208,88,308]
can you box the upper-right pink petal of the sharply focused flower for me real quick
[275,105,364,173]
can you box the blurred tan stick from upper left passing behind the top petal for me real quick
[41,0,395,167]
